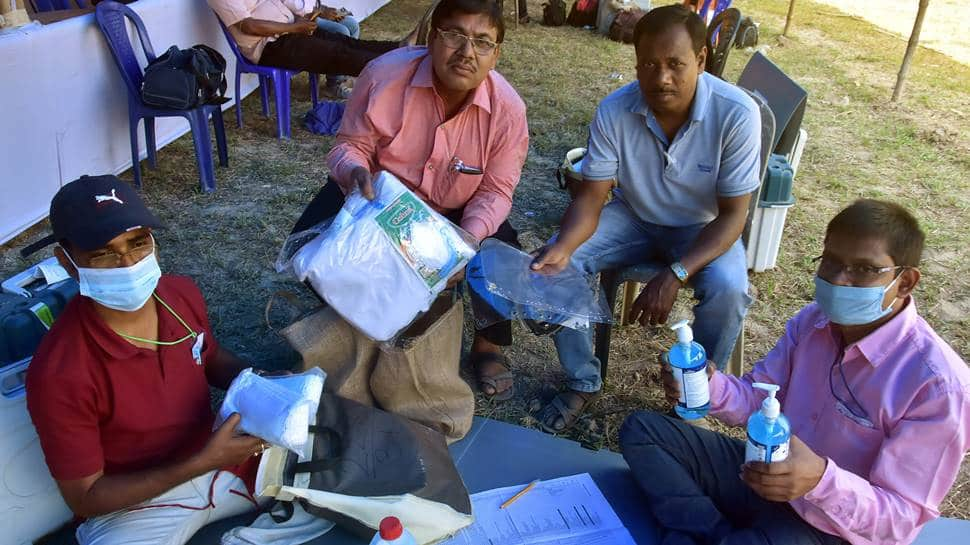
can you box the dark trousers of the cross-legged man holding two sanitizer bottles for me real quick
[620,411,847,545]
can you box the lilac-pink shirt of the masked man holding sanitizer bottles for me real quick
[711,298,970,545]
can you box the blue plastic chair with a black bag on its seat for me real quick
[95,0,229,193]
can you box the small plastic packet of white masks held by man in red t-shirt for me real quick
[213,368,327,455]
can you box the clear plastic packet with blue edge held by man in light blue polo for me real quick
[465,239,612,334]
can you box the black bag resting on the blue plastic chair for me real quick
[141,44,229,110]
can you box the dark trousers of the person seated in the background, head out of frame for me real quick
[259,29,398,76]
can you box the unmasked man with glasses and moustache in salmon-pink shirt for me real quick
[294,0,529,399]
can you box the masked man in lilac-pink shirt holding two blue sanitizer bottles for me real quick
[620,200,970,545]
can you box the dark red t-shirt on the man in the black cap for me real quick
[27,275,231,480]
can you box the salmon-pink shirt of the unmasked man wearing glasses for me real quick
[327,47,529,240]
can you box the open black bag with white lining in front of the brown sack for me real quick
[265,392,473,543]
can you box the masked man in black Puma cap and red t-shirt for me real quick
[27,176,266,545]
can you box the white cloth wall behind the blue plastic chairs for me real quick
[0,0,389,244]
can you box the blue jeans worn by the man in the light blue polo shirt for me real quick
[555,198,751,392]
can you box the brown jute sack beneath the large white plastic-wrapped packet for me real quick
[281,292,475,443]
